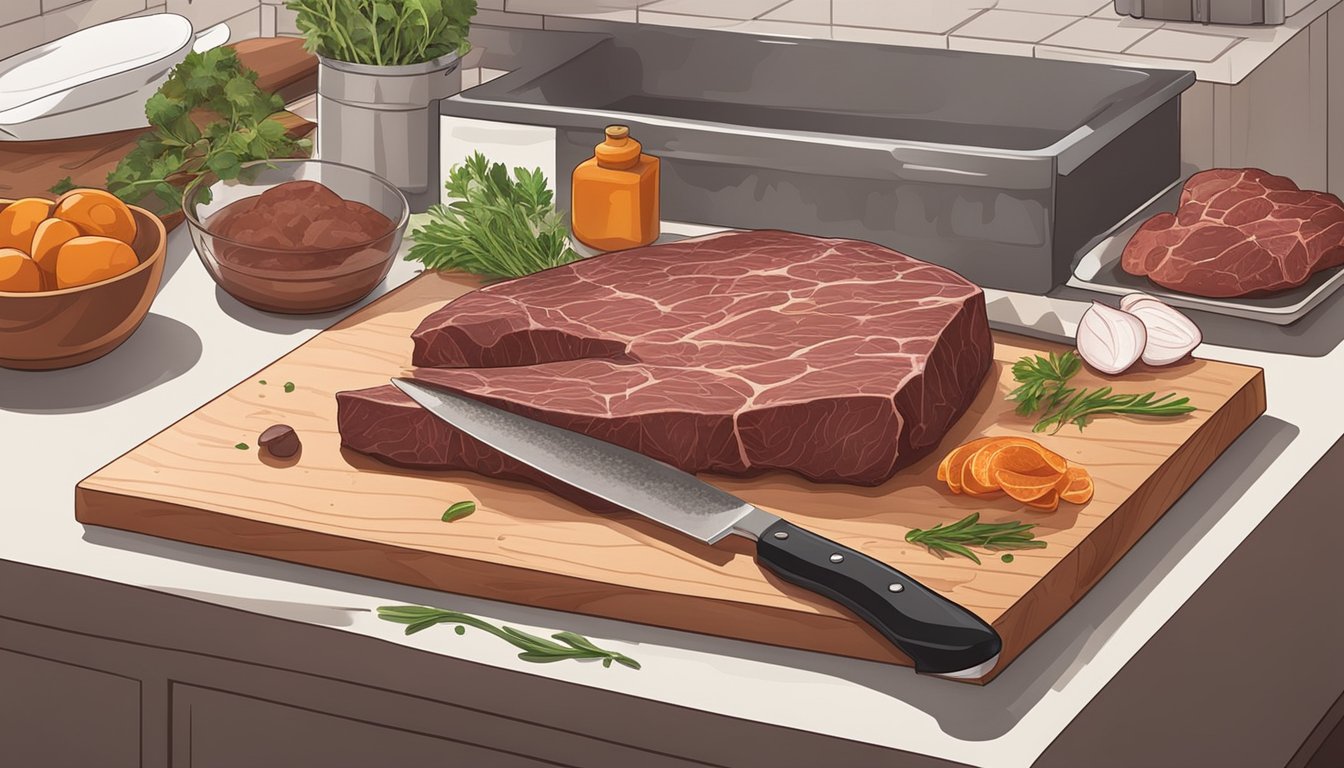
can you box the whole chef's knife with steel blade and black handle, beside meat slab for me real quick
[392,379,1003,678]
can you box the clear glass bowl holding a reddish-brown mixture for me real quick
[181,159,410,315]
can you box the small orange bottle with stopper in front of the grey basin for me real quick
[570,125,659,250]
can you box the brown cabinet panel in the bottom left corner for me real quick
[0,650,140,768]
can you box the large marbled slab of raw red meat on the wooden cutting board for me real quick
[337,231,993,487]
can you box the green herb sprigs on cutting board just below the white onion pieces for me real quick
[1008,350,1195,433]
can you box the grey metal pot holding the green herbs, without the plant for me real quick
[317,54,462,213]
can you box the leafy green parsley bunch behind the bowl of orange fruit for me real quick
[108,47,312,215]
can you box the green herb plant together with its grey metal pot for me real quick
[286,0,476,213]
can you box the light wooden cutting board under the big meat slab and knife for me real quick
[75,273,1265,679]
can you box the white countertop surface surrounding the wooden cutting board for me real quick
[0,118,1344,767]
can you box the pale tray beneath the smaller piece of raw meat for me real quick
[1064,179,1344,325]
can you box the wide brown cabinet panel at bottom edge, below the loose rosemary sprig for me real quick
[172,685,556,768]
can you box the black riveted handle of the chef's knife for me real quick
[757,521,1003,674]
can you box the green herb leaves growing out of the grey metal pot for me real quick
[285,0,476,66]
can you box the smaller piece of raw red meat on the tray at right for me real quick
[1121,168,1344,297]
